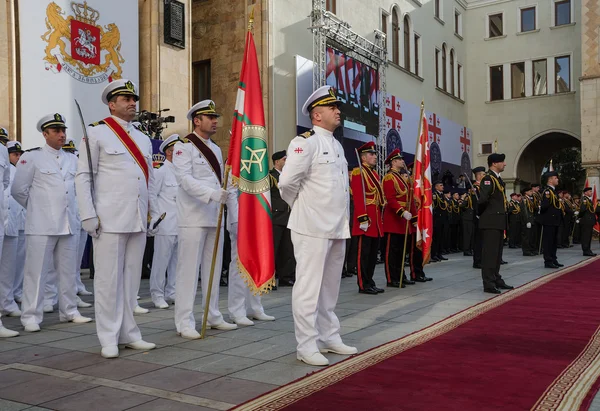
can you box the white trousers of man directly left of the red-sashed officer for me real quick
[21,235,81,326]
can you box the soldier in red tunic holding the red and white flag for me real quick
[383,149,416,288]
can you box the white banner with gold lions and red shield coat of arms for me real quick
[18,0,139,148]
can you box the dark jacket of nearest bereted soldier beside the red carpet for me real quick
[478,170,507,230]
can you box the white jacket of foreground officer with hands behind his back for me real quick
[279,126,350,239]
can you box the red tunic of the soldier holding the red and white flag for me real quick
[383,170,416,235]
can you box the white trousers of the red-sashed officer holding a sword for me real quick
[93,232,146,347]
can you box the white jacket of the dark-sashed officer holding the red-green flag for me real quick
[172,136,237,227]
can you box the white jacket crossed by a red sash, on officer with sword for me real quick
[75,116,154,234]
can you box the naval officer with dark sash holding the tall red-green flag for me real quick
[173,100,237,339]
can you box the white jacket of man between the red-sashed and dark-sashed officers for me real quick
[150,160,179,235]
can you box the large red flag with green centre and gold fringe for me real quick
[227,30,275,294]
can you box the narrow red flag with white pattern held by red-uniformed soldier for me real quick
[413,111,433,264]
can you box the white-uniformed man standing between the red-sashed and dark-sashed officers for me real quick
[150,134,181,308]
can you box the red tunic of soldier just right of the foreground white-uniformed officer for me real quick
[350,164,385,237]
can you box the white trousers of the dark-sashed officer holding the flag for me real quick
[175,227,223,332]
